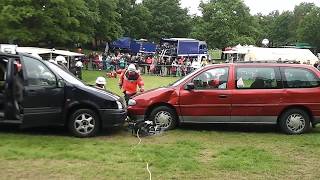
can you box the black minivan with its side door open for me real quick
[0,53,127,137]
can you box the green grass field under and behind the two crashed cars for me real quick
[0,72,320,180]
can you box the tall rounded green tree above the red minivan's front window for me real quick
[195,0,257,48]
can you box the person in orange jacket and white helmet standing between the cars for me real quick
[119,64,144,102]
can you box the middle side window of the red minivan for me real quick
[236,67,278,89]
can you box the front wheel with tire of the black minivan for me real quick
[68,109,100,138]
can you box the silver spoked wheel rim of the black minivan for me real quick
[74,113,95,134]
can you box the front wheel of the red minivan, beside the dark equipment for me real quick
[150,106,177,131]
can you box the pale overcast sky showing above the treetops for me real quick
[181,0,320,15]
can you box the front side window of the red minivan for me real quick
[192,68,229,89]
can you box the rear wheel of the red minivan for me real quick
[279,109,310,134]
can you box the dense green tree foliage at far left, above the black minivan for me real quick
[0,0,121,46]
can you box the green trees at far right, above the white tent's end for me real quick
[255,3,320,48]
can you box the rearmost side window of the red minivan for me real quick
[282,68,320,88]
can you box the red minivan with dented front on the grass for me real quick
[128,63,320,134]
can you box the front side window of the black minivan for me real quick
[23,56,57,87]
